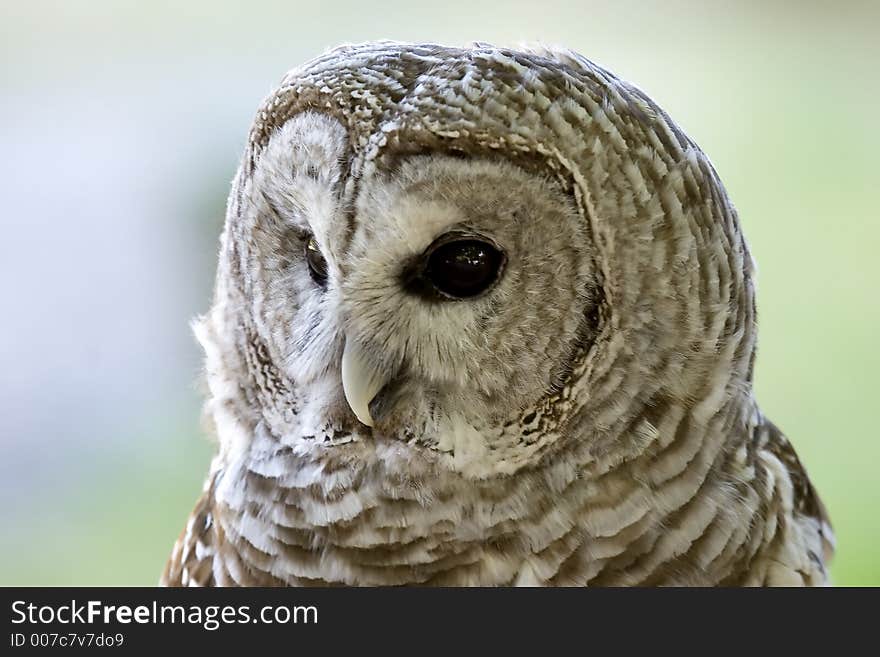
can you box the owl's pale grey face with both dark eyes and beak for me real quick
[238,112,597,468]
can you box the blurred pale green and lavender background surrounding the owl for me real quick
[0,0,880,585]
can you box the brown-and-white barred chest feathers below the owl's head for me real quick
[174,402,825,586]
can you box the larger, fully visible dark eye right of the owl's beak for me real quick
[422,237,504,299]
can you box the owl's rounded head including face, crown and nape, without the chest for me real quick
[197,42,754,478]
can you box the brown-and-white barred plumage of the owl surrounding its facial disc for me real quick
[162,42,833,586]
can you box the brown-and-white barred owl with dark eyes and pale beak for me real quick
[161,42,833,586]
